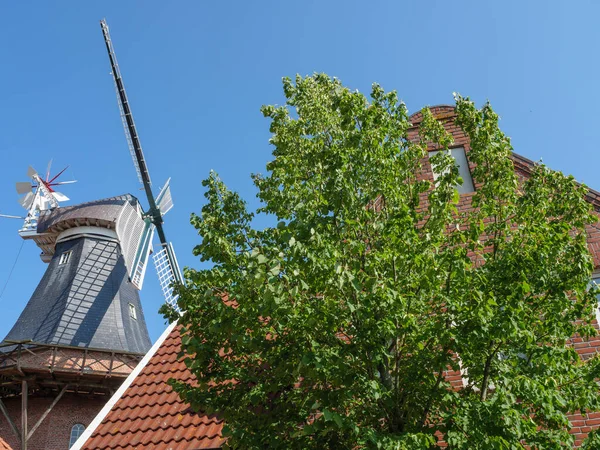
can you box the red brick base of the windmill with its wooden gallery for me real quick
[0,345,141,450]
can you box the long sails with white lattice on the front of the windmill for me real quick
[100,19,182,307]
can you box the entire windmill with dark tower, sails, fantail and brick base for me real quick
[0,21,181,450]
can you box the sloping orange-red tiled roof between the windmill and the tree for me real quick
[81,327,224,450]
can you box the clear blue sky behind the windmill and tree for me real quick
[0,0,600,340]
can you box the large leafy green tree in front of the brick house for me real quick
[167,74,600,449]
